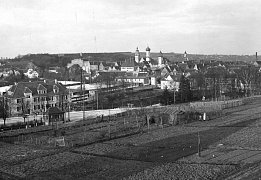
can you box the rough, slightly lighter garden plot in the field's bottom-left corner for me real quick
[0,152,91,177]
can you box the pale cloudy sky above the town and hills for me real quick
[0,0,261,57]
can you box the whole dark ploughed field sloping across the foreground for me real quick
[0,98,261,179]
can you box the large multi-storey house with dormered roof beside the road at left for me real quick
[5,80,70,116]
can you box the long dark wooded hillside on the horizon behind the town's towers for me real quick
[8,52,260,68]
